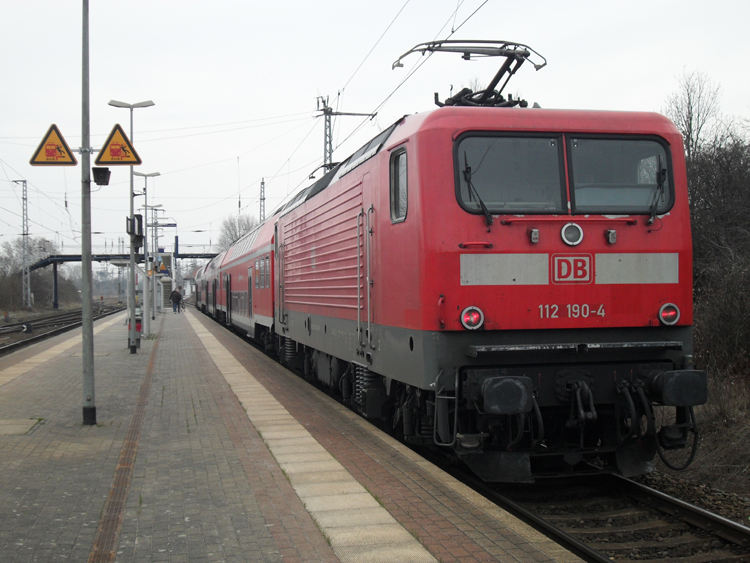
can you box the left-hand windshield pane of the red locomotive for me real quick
[455,135,565,215]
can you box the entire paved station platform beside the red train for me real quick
[0,309,579,563]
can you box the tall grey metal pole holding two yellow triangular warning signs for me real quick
[81,0,96,425]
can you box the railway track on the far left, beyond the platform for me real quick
[0,305,125,356]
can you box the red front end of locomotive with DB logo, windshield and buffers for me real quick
[407,108,707,481]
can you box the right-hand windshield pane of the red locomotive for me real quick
[568,137,672,214]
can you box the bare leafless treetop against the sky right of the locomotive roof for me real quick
[665,71,721,160]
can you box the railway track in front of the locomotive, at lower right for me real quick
[478,475,750,563]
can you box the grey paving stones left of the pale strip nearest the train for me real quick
[0,313,338,563]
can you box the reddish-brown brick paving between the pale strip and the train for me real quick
[189,313,579,563]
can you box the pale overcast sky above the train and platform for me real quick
[0,0,750,253]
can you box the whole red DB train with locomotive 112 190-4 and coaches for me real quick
[196,42,708,483]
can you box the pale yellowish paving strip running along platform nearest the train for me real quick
[187,315,437,563]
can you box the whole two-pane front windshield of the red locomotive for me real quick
[454,133,673,216]
